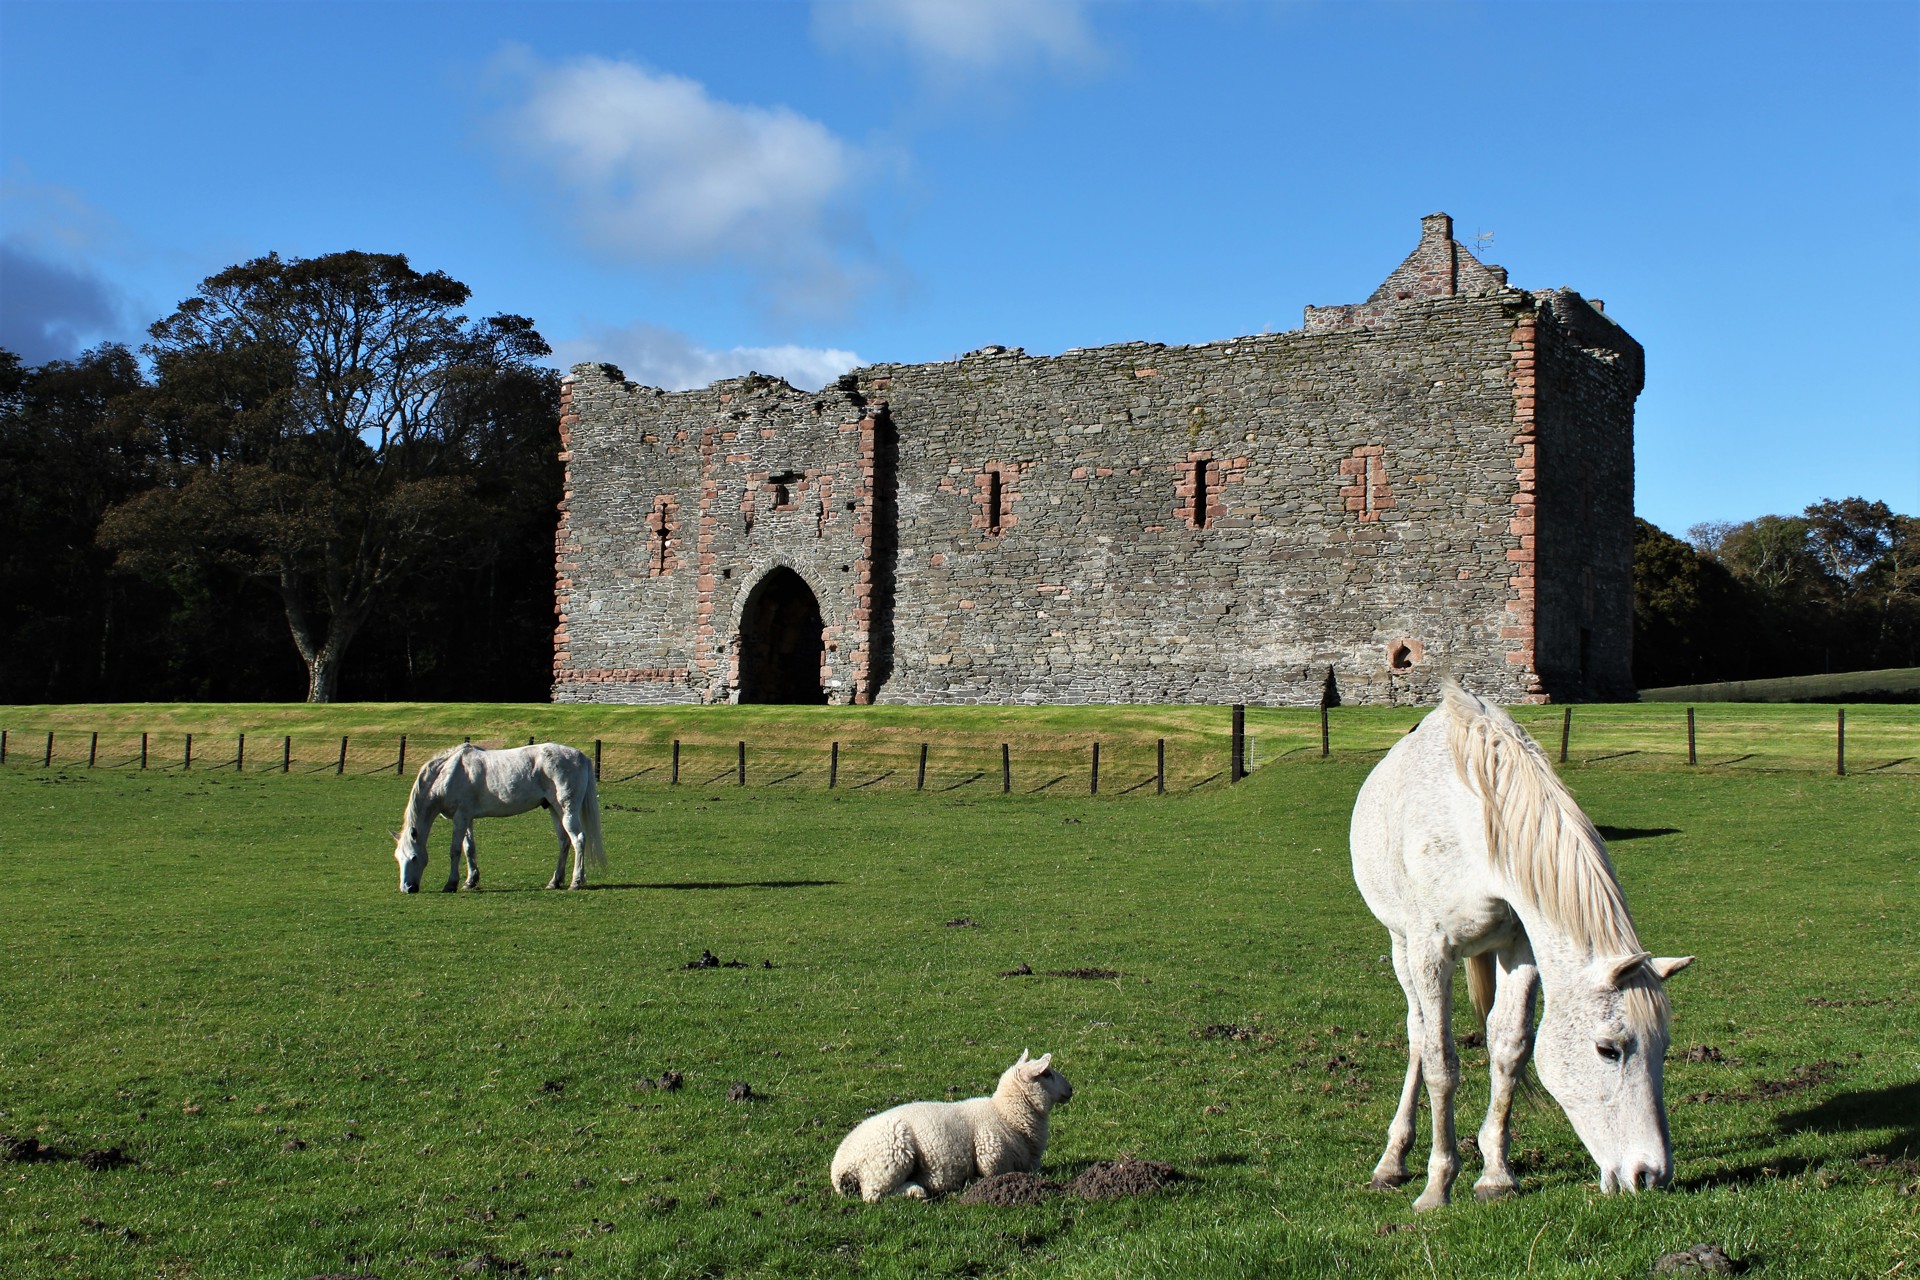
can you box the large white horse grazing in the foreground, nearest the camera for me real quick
[1354,683,1693,1209]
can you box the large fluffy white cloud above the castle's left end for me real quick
[497,50,876,315]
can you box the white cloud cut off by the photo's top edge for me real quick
[814,0,1098,79]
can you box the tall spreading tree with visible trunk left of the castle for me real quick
[100,251,557,702]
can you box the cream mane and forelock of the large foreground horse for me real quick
[1440,681,1670,1032]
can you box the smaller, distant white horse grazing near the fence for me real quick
[392,743,607,894]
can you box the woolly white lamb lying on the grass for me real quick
[833,1050,1073,1203]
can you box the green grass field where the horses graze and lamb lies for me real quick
[0,706,1920,1280]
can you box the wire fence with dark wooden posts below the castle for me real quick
[0,702,1920,796]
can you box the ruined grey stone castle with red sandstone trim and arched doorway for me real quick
[553,213,1642,704]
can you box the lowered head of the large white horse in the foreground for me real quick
[1534,952,1693,1192]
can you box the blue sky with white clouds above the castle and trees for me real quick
[0,0,1920,533]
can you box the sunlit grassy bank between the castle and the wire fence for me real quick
[0,702,1920,782]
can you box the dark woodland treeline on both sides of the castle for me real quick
[0,253,1920,702]
